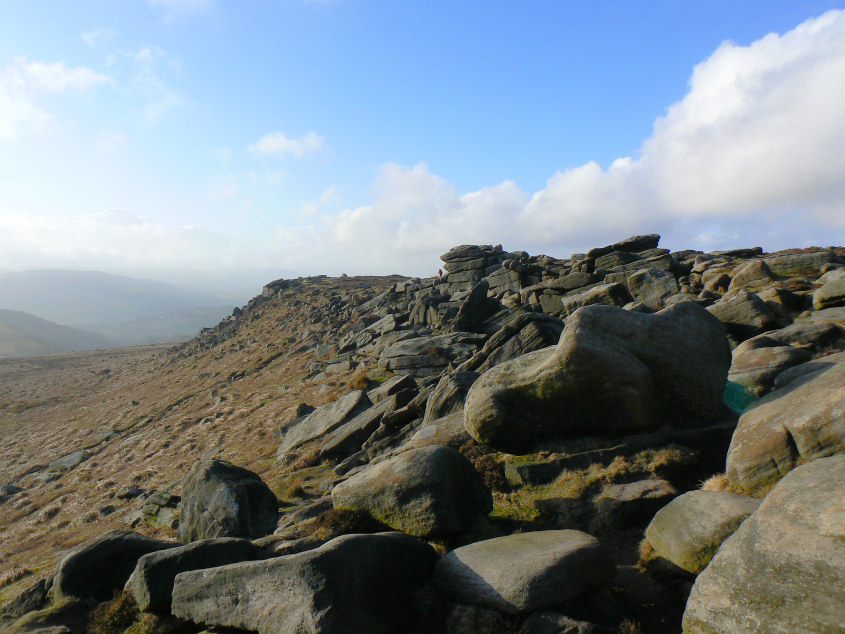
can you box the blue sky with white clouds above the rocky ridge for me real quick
[0,0,845,277]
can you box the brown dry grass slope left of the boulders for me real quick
[0,278,392,574]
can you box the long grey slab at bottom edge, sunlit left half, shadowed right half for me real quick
[173,533,437,634]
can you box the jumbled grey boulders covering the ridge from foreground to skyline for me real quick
[0,234,845,634]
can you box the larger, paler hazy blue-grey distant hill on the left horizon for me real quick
[0,270,235,345]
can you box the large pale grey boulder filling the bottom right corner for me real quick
[683,455,845,634]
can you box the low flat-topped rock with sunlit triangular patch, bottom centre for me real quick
[434,530,616,614]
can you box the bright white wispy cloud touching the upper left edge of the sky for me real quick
[0,57,108,138]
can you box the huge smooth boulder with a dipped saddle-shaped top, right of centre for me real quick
[464,302,730,453]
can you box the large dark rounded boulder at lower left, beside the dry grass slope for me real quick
[50,530,177,603]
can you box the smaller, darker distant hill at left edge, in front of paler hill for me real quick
[0,309,116,357]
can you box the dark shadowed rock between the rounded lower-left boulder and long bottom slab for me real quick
[125,537,262,613]
